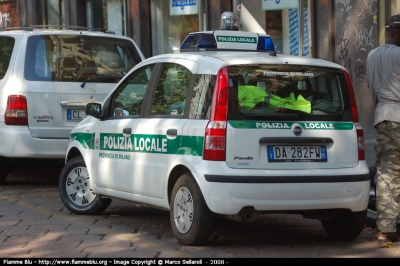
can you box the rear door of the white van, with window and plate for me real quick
[24,33,144,138]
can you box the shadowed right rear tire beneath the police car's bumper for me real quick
[321,210,367,240]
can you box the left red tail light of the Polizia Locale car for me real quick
[203,67,229,161]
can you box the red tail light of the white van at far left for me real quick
[4,95,28,126]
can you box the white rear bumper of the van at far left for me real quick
[0,122,69,159]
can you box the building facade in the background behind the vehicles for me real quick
[4,0,400,131]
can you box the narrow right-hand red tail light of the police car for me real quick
[343,71,365,161]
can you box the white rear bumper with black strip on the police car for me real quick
[192,161,370,215]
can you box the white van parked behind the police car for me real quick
[0,26,144,183]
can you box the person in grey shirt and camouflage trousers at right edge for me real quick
[366,14,400,243]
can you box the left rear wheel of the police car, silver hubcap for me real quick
[170,174,215,246]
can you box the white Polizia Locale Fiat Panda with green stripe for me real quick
[59,12,370,245]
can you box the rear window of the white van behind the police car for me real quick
[25,35,141,83]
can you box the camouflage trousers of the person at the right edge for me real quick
[375,121,400,240]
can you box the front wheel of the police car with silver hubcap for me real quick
[58,156,112,214]
